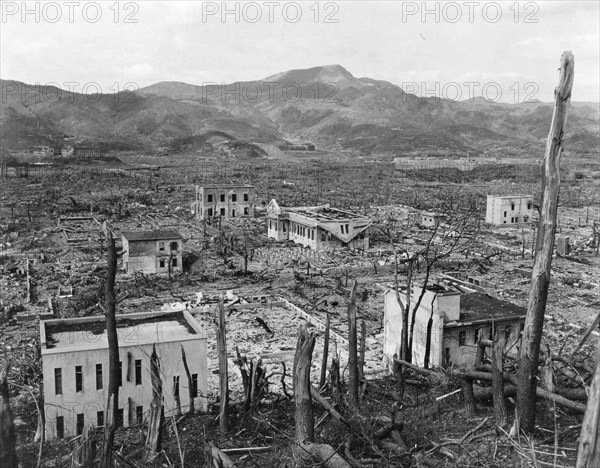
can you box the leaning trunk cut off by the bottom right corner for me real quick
[575,340,600,468]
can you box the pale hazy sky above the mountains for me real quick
[0,0,600,102]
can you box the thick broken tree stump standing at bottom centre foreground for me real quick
[294,324,316,445]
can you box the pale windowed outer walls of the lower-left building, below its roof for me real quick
[42,336,207,440]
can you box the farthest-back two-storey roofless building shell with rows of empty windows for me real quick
[192,185,254,219]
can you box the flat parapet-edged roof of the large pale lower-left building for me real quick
[40,311,203,351]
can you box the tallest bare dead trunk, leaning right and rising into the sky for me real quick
[516,51,574,433]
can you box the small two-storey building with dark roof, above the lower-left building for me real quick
[122,231,183,274]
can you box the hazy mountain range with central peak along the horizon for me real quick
[0,65,600,156]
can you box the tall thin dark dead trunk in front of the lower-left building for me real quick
[100,236,120,468]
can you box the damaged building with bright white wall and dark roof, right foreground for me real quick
[383,285,526,368]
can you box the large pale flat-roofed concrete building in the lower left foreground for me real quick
[40,311,207,440]
